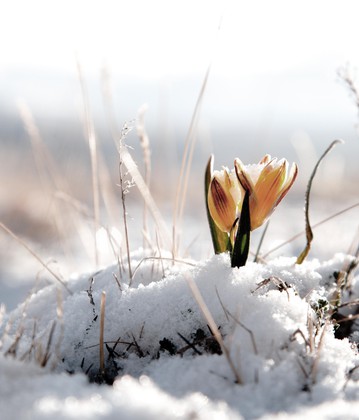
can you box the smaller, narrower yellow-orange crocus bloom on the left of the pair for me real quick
[207,168,244,233]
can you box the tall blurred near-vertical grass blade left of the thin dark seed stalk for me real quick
[77,61,100,266]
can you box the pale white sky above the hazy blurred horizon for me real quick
[0,0,359,176]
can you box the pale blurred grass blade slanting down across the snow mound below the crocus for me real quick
[186,276,243,384]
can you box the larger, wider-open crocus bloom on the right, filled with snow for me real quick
[234,155,298,230]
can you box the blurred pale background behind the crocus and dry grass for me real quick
[0,0,359,309]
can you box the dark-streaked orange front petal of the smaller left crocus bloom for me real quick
[208,170,237,232]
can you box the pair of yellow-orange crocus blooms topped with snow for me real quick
[207,155,298,246]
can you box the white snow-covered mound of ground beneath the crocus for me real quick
[0,249,359,419]
